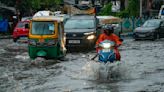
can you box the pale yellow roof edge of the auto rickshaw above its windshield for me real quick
[32,16,64,22]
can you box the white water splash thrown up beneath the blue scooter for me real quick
[77,61,129,81]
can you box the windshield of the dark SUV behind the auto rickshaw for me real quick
[65,19,95,29]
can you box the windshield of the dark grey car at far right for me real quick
[143,20,160,27]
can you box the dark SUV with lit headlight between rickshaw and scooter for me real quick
[65,15,99,49]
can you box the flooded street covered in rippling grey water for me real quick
[0,38,164,92]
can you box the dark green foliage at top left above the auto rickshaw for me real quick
[0,0,63,13]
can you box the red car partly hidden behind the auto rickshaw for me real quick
[13,20,30,42]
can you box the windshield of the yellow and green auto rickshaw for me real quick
[32,21,55,35]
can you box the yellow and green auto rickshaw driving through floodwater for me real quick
[28,16,66,59]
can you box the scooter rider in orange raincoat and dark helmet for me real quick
[96,25,122,61]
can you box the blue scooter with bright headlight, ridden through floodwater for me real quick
[92,40,116,64]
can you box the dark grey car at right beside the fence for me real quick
[134,19,164,40]
